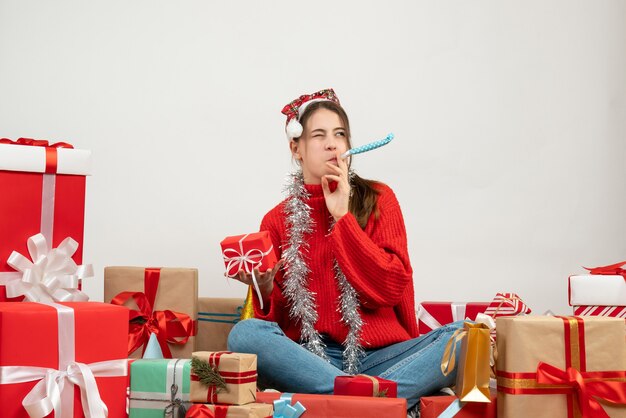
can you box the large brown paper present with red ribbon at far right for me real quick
[496,316,626,418]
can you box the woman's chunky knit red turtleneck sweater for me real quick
[254,184,418,349]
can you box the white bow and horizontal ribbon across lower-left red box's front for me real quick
[0,360,127,418]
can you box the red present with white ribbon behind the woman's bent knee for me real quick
[417,302,489,334]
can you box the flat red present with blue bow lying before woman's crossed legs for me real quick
[256,392,407,418]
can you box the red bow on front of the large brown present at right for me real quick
[537,362,626,418]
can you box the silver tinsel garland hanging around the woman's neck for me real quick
[283,171,364,374]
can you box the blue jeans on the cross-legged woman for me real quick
[228,319,463,408]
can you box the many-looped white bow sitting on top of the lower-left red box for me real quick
[6,234,93,302]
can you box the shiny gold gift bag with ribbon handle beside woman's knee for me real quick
[441,322,491,402]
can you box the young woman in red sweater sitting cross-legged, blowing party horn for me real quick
[228,89,462,407]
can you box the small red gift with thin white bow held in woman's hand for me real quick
[220,231,278,277]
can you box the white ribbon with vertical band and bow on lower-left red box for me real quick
[0,303,128,418]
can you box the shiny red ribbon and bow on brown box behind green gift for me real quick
[111,268,195,358]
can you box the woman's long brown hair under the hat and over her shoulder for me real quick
[293,100,379,229]
